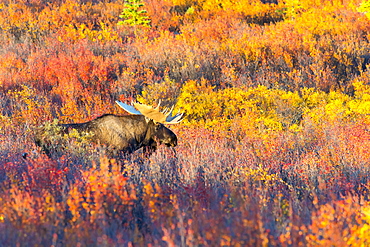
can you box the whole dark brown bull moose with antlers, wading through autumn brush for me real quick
[36,101,183,154]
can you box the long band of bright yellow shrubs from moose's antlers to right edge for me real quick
[158,76,370,137]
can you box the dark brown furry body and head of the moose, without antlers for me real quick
[36,114,177,153]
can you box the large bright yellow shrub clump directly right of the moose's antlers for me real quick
[177,81,303,137]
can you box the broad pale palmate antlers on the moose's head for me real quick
[116,100,183,124]
